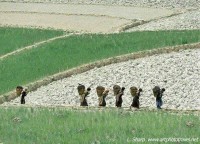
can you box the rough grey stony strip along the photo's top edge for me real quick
[0,0,200,9]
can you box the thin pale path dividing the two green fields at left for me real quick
[0,33,75,60]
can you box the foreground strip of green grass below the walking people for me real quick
[0,108,200,144]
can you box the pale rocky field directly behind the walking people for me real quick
[3,49,200,110]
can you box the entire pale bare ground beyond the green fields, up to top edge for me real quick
[0,0,200,33]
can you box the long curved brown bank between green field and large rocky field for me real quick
[0,42,200,104]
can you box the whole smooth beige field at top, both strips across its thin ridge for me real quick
[0,2,176,33]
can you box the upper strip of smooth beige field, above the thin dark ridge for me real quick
[0,2,176,20]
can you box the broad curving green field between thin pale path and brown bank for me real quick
[0,30,200,94]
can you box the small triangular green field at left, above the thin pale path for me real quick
[0,27,64,56]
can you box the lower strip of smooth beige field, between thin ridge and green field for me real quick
[0,13,129,33]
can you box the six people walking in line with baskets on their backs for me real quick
[16,84,165,109]
